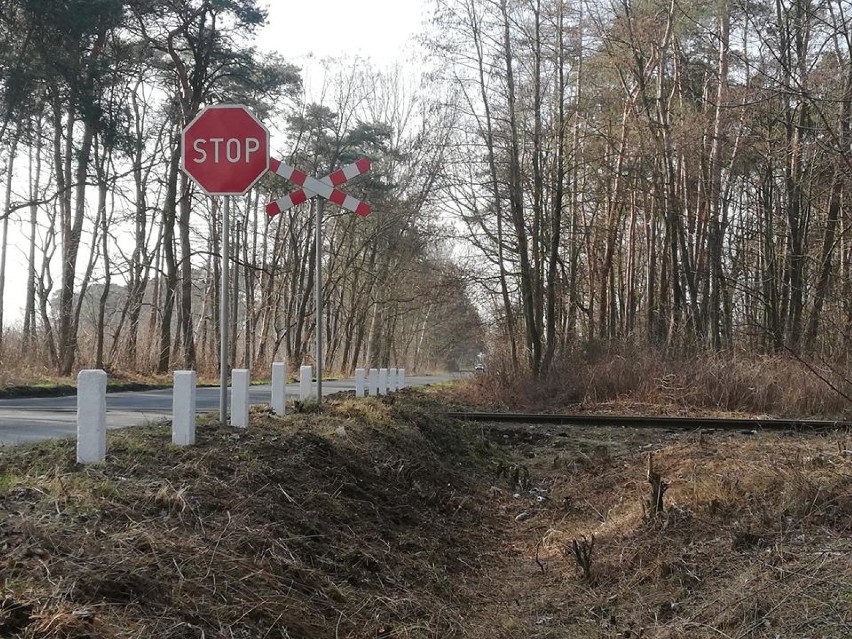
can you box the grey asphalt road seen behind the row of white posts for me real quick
[0,375,453,444]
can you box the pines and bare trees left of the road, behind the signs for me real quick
[0,0,481,375]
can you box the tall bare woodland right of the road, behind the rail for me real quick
[433,0,852,380]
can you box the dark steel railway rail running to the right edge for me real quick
[445,411,852,432]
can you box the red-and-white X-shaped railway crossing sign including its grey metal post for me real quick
[266,158,372,404]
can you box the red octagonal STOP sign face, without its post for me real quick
[181,104,269,195]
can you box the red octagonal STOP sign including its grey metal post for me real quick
[180,104,269,425]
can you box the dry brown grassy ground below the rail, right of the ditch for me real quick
[471,425,852,639]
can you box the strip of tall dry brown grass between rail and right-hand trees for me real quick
[459,350,852,418]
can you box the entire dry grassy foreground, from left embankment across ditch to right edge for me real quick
[0,390,852,639]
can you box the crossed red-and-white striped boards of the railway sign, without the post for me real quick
[266,158,373,217]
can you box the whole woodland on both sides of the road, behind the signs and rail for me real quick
[0,0,852,376]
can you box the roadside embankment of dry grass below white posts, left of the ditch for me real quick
[0,396,502,639]
